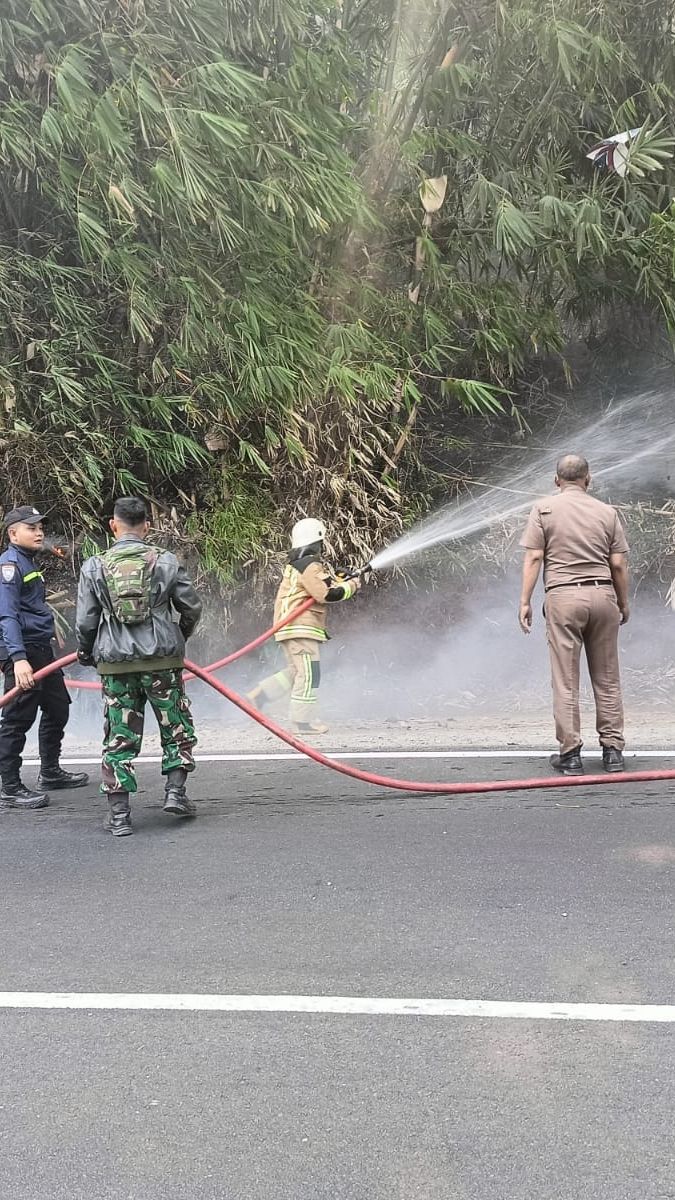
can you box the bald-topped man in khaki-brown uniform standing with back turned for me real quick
[519,455,629,775]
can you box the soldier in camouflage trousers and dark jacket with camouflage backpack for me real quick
[76,497,202,836]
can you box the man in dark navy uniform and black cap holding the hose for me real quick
[0,505,89,809]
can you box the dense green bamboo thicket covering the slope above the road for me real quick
[0,0,675,577]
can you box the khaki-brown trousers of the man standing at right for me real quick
[544,583,625,754]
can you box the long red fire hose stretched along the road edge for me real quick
[5,648,675,796]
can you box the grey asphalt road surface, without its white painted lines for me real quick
[0,760,675,1200]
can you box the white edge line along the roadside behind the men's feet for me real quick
[24,746,675,767]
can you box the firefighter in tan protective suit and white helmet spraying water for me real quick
[249,517,360,733]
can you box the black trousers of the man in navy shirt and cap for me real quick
[0,642,71,784]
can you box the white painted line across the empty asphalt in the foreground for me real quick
[0,991,675,1024]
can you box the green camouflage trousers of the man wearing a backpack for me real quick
[101,671,197,794]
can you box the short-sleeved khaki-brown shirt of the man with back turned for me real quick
[520,487,628,589]
